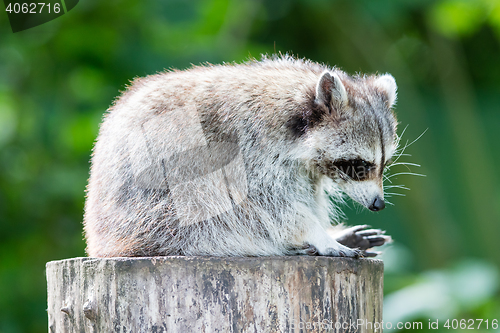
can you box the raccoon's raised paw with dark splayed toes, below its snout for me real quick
[327,224,392,257]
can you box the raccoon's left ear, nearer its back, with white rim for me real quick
[316,71,347,109]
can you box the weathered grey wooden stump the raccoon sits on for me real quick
[47,256,383,333]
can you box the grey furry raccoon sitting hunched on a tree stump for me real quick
[84,56,397,257]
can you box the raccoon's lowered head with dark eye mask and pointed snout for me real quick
[294,71,397,211]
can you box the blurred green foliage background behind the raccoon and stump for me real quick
[0,0,500,333]
